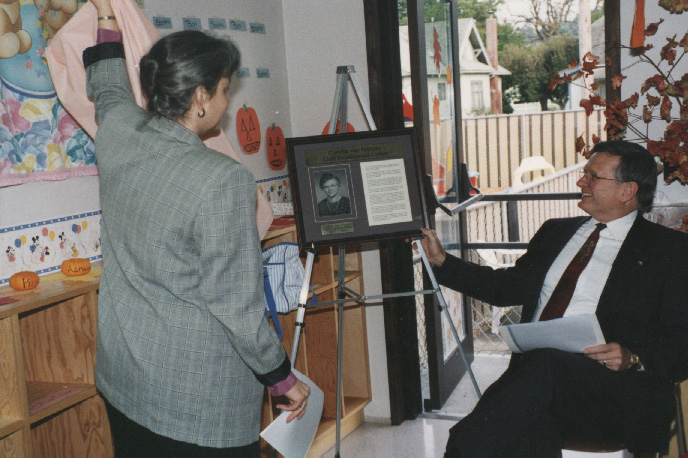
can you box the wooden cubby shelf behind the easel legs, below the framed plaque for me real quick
[262,222,371,457]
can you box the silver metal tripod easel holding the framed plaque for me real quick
[291,65,481,458]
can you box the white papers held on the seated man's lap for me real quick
[499,314,606,353]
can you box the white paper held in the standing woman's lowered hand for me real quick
[260,370,325,458]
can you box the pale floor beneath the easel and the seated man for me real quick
[323,355,631,458]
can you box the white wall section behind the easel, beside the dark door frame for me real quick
[282,0,391,421]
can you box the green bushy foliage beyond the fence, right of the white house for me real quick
[499,35,578,111]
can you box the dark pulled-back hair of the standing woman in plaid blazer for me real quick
[140,30,240,120]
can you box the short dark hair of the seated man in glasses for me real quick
[592,140,657,213]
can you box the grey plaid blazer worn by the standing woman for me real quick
[84,43,290,447]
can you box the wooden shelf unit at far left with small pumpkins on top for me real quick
[0,280,113,458]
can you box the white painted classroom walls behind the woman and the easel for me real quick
[0,0,390,422]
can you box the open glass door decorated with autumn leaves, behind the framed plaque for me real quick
[398,0,473,410]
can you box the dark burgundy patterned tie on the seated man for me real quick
[540,223,607,321]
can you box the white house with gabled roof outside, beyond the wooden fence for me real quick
[399,18,511,123]
